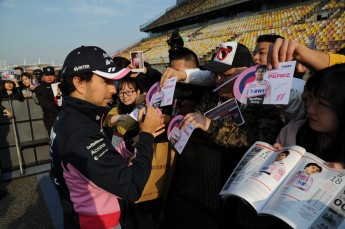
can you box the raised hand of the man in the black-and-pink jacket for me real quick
[138,105,163,136]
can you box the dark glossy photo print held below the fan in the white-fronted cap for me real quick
[204,98,244,126]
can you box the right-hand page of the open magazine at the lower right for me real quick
[262,153,345,229]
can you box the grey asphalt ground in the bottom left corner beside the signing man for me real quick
[0,173,62,229]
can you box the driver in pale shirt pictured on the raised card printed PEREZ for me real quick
[241,65,271,104]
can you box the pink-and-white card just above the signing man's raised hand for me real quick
[146,77,177,107]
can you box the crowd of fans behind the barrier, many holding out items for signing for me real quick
[1,30,345,226]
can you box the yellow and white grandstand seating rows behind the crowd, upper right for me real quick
[115,0,345,65]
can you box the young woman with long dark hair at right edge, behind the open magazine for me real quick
[275,64,345,168]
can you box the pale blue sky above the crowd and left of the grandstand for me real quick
[0,0,176,67]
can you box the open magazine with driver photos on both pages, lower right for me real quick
[220,141,345,228]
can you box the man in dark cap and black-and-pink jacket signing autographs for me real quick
[51,46,164,229]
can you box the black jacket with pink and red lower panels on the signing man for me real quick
[51,97,154,228]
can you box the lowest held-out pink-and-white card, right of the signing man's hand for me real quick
[167,115,195,154]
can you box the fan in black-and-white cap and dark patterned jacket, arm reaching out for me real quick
[181,42,285,149]
